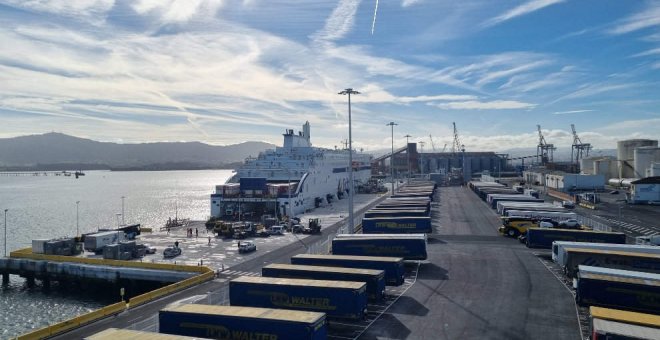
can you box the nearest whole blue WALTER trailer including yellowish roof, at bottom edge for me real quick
[158,304,327,340]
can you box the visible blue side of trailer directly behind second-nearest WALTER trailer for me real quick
[261,266,385,301]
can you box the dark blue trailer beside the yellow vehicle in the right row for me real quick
[525,228,626,249]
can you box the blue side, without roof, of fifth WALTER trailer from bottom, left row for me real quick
[332,238,428,260]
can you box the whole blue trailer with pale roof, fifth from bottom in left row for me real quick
[332,234,428,260]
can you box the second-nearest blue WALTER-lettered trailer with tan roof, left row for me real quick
[229,276,367,320]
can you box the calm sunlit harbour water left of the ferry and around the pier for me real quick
[0,170,232,339]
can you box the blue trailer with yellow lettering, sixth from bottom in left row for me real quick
[362,216,433,234]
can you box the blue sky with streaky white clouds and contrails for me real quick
[0,0,660,151]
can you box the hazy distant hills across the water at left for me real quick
[0,132,275,171]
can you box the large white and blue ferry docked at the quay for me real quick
[211,122,372,220]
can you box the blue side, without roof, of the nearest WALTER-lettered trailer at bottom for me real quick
[158,306,327,340]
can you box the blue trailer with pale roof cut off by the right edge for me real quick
[575,266,660,314]
